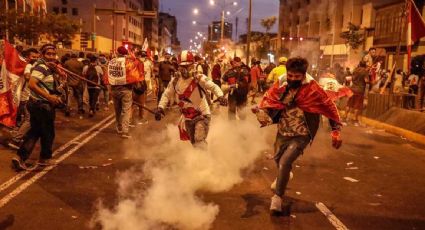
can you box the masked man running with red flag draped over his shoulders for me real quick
[253,57,342,214]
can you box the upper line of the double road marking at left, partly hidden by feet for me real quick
[0,114,114,192]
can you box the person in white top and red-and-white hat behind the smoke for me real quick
[155,51,227,147]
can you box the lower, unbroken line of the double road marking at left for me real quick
[0,117,115,208]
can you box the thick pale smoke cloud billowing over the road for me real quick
[94,110,270,230]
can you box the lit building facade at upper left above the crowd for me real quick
[46,0,157,53]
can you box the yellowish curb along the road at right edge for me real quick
[360,117,425,145]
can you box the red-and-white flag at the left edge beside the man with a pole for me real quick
[0,41,27,127]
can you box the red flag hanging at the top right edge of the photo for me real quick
[407,0,425,71]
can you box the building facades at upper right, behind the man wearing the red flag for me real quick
[276,0,423,70]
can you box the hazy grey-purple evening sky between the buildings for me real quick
[160,0,279,49]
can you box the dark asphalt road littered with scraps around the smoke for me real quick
[0,101,425,230]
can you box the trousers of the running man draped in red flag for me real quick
[274,132,310,197]
